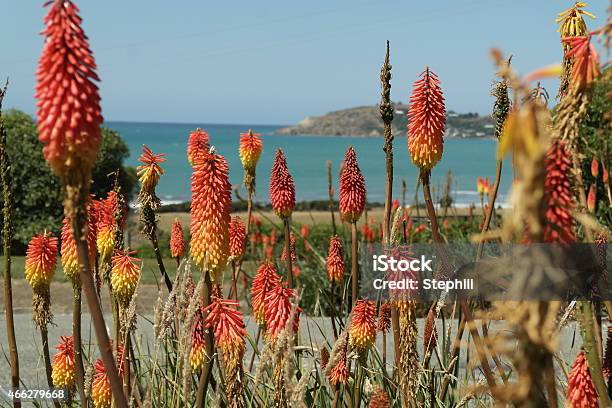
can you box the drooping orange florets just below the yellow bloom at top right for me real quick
[563,35,600,90]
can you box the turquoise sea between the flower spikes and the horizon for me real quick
[105,122,511,206]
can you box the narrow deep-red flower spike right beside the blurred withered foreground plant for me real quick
[544,140,576,244]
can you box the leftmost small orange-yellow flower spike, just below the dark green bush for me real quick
[25,233,58,288]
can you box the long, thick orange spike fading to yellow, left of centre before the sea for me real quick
[191,149,232,278]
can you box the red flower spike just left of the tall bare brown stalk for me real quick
[339,146,366,222]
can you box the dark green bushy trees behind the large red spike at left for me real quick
[0,110,137,253]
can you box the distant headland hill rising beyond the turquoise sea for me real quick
[275,103,494,139]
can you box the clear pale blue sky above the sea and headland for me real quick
[0,0,607,124]
